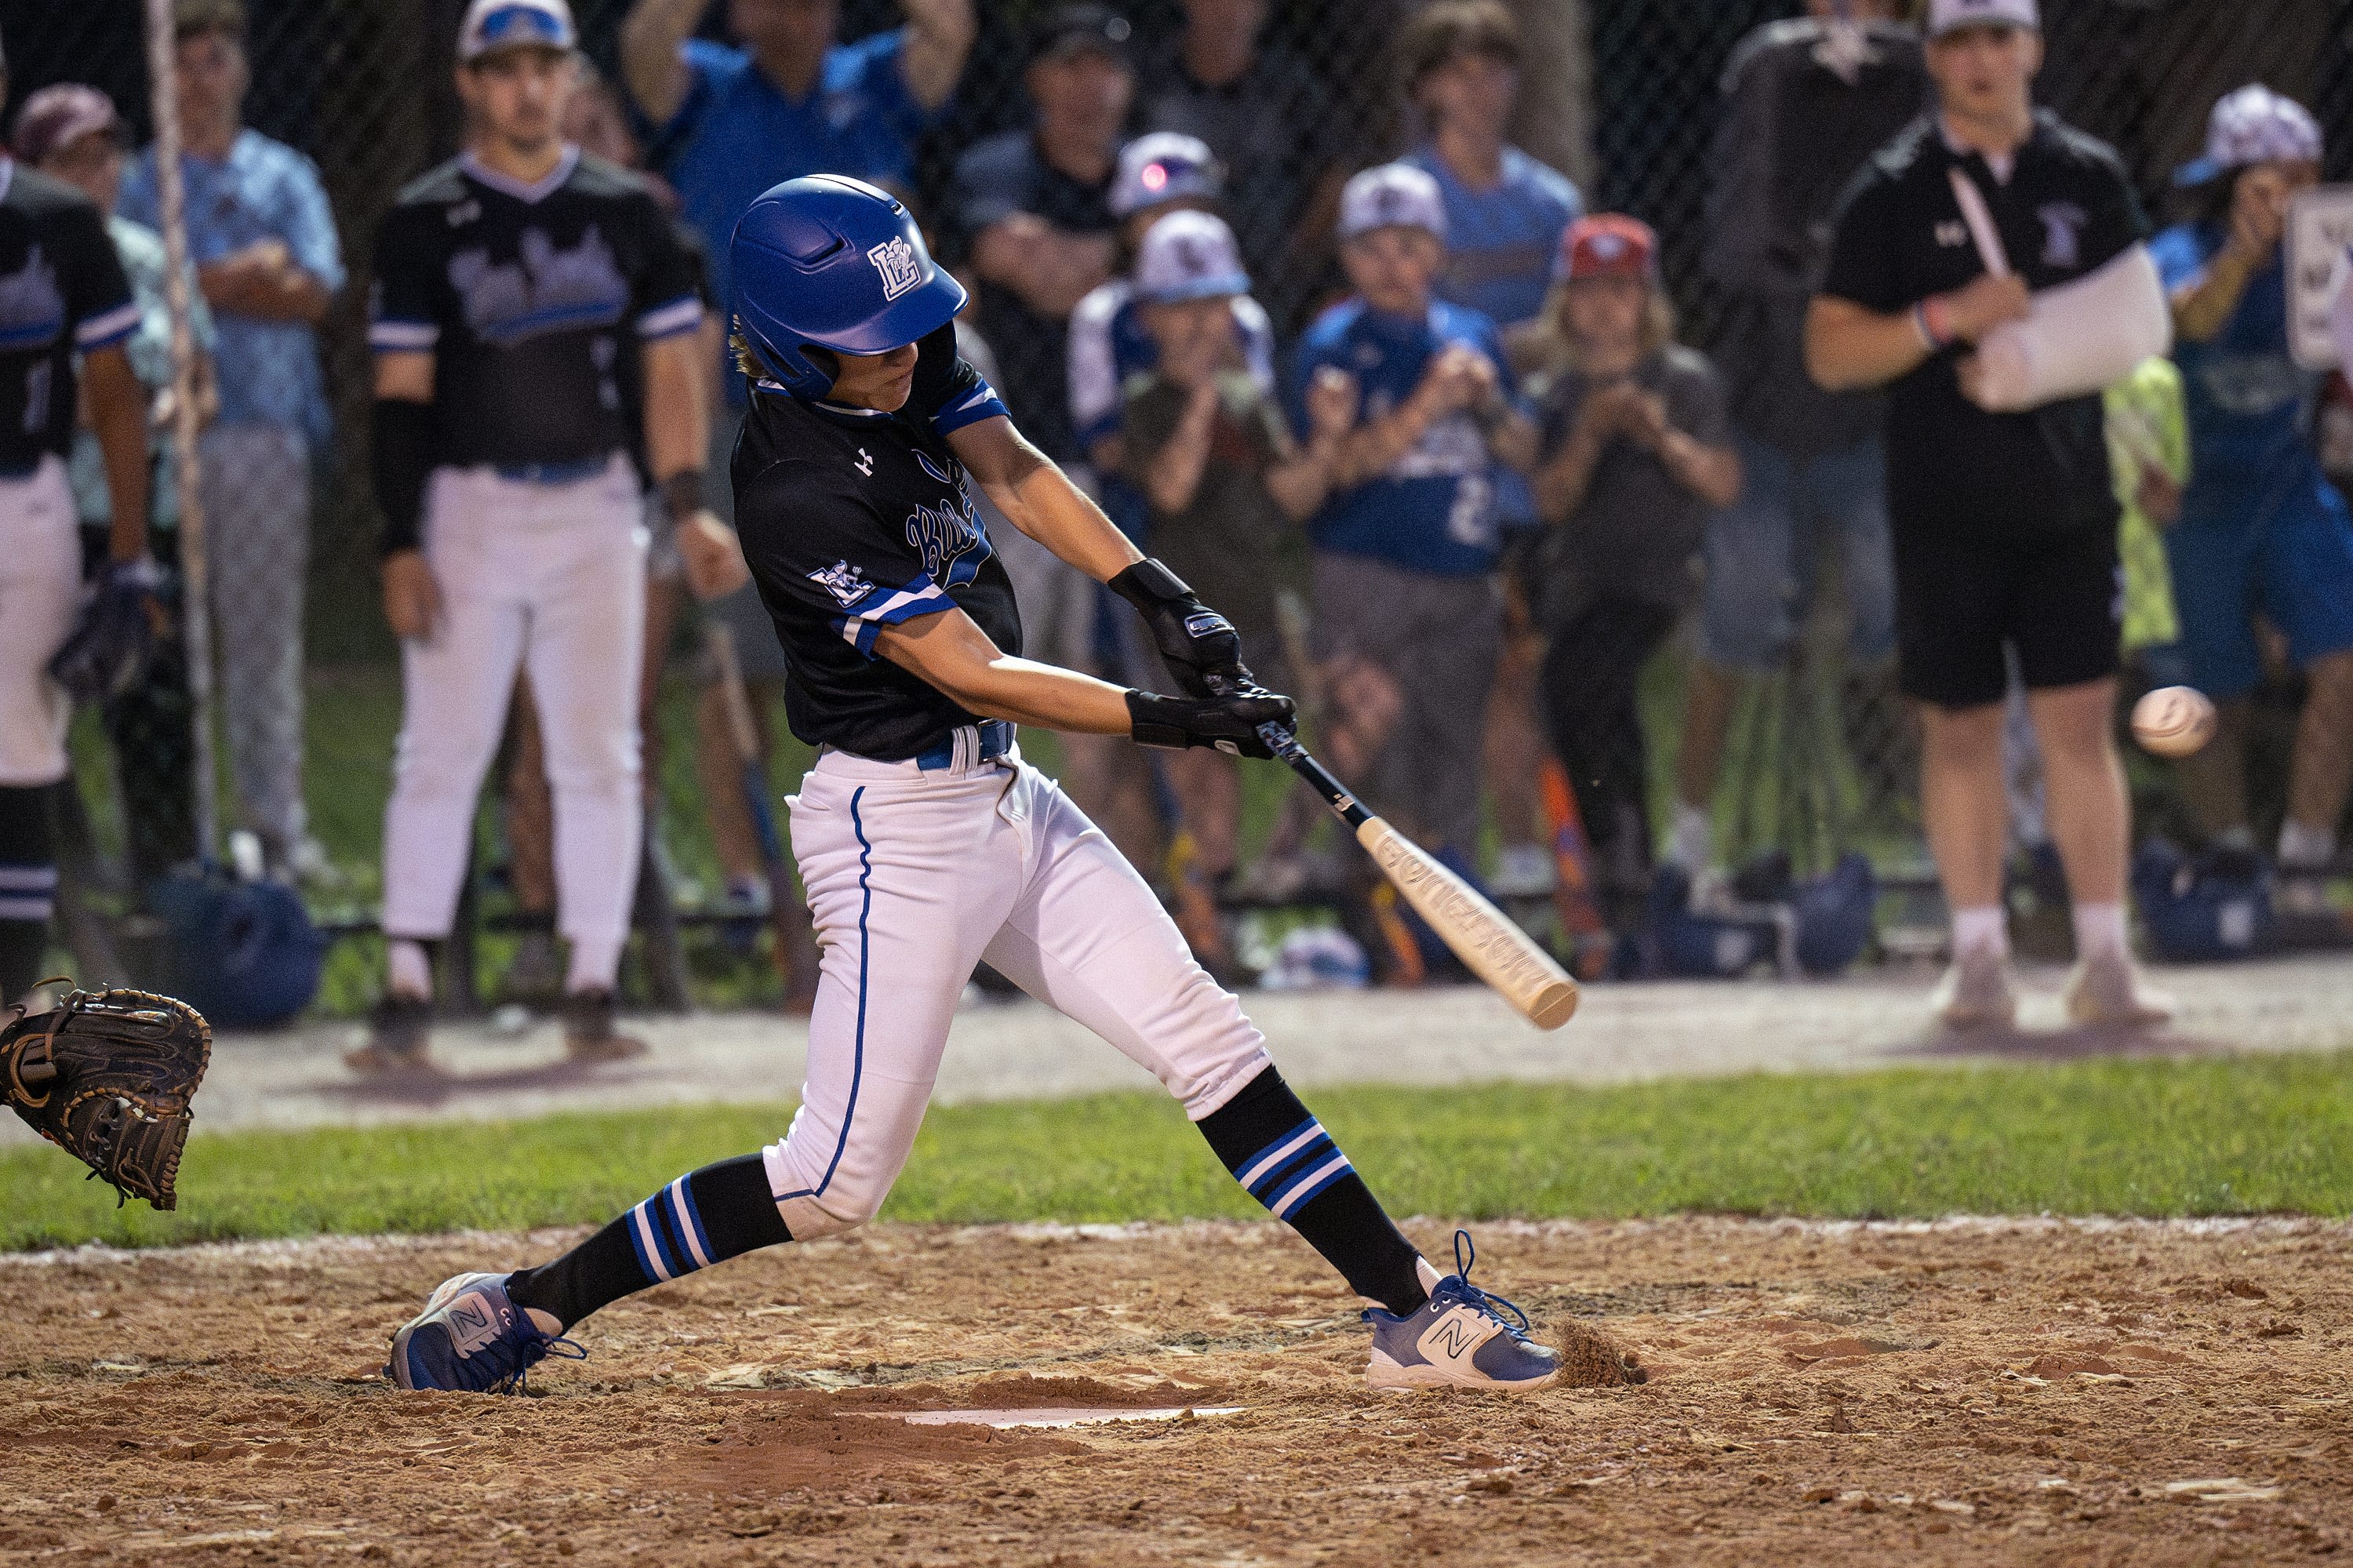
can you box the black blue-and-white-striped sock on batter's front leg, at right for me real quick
[1198,1067,1431,1316]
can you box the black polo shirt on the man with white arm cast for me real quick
[1821,111,2148,532]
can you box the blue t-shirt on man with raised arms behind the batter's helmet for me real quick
[659,28,932,337]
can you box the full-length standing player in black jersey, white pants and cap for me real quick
[348,0,734,1071]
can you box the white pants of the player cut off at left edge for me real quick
[0,457,82,789]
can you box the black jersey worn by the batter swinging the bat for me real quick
[732,325,1021,762]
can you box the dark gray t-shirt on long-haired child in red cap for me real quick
[1529,346,1732,628]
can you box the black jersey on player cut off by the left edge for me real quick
[0,158,139,475]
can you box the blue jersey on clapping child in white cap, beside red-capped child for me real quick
[1289,299,1513,577]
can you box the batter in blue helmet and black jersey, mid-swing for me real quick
[386,174,1558,1389]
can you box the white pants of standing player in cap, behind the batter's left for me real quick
[384,457,645,984]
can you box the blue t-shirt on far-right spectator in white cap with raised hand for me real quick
[2151,224,2318,487]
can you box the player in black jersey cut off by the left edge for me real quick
[0,33,155,1001]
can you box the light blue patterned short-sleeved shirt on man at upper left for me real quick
[115,129,344,442]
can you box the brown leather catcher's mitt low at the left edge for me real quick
[0,991,212,1208]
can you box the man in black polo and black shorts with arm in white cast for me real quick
[1807,0,2172,1029]
